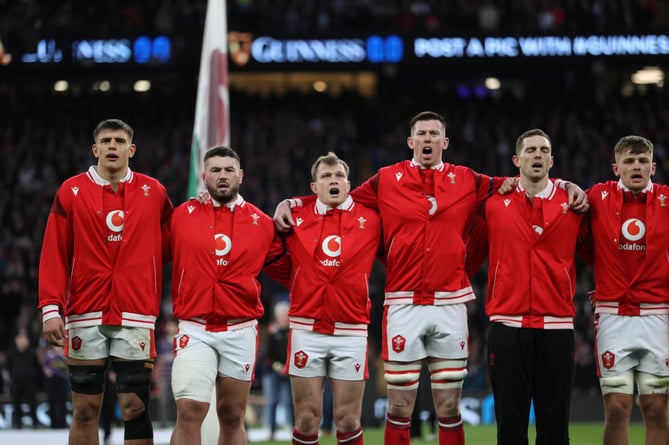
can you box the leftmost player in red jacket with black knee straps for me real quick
[39,119,172,445]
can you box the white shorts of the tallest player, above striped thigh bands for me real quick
[381,303,469,362]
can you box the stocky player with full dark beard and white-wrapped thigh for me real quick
[170,147,284,445]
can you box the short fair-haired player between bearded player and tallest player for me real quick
[267,152,381,445]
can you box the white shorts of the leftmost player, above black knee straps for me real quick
[65,325,156,360]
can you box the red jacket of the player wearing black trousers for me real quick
[481,182,583,329]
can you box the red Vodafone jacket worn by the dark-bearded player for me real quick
[172,196,283,331]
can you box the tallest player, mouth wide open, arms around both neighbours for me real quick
[274,111,585,445]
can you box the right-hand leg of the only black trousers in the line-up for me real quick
[532,329,574,445]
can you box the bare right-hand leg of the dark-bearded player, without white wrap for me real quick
[216,376,251,445]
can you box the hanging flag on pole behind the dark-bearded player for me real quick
[188,0,230,197]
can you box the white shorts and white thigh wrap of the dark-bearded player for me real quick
[172,323,258,403]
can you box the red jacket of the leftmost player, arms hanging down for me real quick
[39,167,172,329]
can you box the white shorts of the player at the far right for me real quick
[595,314,669,377]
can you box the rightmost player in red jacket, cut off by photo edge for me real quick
[583,136,669,445]
